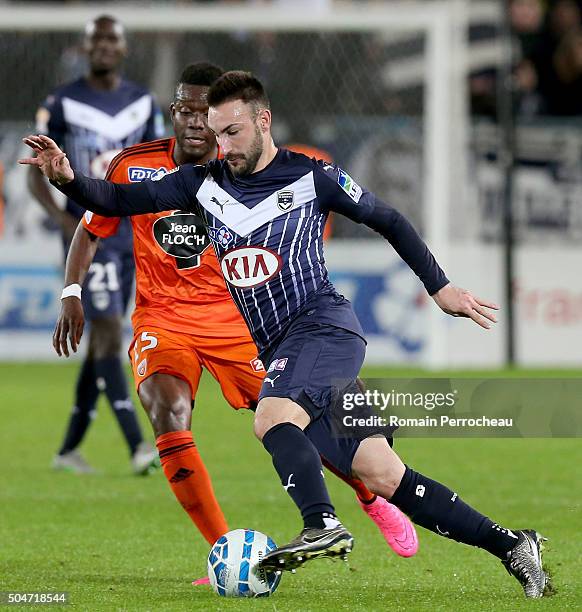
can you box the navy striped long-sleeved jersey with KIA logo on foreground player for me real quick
[61,149,448,355]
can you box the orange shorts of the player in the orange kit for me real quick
[129,325,265,409]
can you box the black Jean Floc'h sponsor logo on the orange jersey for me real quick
[153,213,210,270]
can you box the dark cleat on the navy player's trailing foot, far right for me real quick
[502,529,551,597]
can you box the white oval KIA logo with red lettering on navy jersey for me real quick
[220,247,283,289]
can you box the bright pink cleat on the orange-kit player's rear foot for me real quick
[360,496,418,557]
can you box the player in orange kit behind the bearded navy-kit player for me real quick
[53,62,418,557]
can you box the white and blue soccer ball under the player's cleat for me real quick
[208,529,281,597]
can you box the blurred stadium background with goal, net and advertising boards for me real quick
[0,0,582,368]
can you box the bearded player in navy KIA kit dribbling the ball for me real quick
[21,71,547,597]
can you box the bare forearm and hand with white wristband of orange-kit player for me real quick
[53,223,99,357]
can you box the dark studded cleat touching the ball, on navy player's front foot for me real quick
[260,524,354,571]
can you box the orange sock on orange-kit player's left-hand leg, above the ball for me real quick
[156,431,228,544]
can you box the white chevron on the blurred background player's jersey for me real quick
[62,94,152,141]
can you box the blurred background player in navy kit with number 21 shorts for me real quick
[29,16,163,473]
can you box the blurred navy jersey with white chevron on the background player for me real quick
[36,78,164,249]
